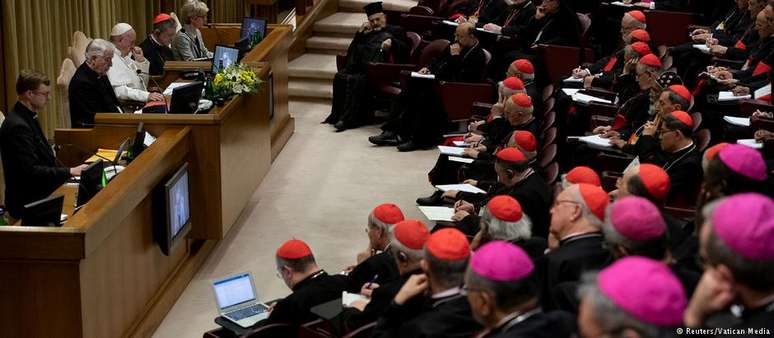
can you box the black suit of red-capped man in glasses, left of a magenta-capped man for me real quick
[536,232,612,309]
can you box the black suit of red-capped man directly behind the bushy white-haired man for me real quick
[457,169,553,238]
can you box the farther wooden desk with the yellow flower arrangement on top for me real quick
[94,63,271,239]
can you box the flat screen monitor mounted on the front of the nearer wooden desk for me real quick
[154,163,191,255]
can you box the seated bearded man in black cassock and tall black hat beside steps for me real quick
[324,2,410,131]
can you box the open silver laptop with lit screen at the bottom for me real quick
[212,272,269,327]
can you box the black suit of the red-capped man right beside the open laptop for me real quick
[268,270,347,326]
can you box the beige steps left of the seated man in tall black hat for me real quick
[288,0,417,101]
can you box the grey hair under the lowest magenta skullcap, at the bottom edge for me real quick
[578,272,665,338]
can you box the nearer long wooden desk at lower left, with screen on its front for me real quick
[0,127,214,337]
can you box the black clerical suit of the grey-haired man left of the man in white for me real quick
[68,62,119,128]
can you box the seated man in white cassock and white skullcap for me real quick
[107,22,164,102]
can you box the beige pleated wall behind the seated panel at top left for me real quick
[0,0,244,136]
